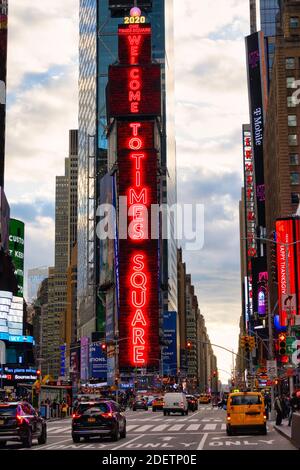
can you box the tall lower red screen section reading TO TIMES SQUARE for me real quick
[118,121,159,368]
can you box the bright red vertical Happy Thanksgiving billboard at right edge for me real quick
[276,219,298,326]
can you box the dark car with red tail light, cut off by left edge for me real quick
[0,401,47,448]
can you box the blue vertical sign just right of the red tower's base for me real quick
[163,312,177,375]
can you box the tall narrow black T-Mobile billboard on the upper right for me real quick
[246,32,267,227]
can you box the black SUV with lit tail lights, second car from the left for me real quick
[72,400,126,443]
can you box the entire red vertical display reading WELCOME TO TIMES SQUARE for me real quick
[107,25,161,370]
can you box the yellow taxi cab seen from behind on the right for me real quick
[226,392,267,436]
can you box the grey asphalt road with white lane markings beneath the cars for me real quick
[2,405,296,452]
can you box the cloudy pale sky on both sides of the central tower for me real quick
[5,0,249,382]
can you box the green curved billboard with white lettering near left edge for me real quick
[9,219,25,297]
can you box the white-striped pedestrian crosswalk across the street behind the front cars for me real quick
[48,420,226,436]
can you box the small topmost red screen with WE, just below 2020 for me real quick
[119,24,151,65]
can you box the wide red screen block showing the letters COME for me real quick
[108,64,161,117]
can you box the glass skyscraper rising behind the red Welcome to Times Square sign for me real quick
[77,0,177,337]
